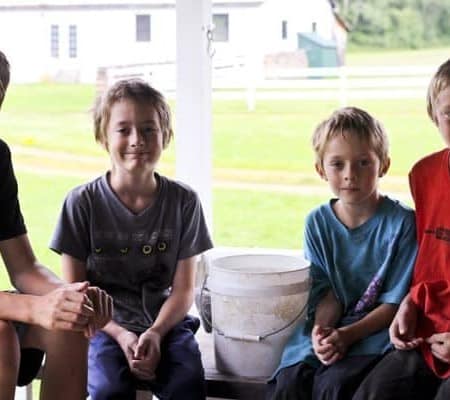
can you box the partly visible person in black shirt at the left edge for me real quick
[0,52,112,400]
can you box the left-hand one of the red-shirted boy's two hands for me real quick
[389,296,423,350]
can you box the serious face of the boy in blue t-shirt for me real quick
[316,134,385,208]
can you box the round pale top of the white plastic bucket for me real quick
[211,254,309,274]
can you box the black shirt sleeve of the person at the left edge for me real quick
[0,139,27,240]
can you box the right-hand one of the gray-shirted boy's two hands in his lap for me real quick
[131,329,161,380]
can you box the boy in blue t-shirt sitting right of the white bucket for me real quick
[268,107,417,400]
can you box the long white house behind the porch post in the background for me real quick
[0,0,342,83]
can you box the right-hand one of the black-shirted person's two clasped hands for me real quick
[84,286,113,338]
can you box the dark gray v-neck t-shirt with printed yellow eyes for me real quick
[50,175,212,332]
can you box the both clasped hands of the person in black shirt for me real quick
[31,282,113,338]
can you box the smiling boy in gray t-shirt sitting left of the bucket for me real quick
[51,80,212,400]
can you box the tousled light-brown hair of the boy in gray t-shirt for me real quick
[93,79,173,148]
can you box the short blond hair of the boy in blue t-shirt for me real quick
[312,107,389,170]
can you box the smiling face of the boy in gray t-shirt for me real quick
[105,99,163,173]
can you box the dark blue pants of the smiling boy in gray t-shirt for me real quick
[88,316,206,400]
